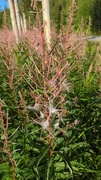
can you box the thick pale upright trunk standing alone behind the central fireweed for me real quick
[42,0,51,50]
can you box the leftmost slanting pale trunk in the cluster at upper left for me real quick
[8,0,19,42]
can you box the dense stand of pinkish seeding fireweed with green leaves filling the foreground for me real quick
[0,1,101,180]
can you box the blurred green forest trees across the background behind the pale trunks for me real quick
[0,0,101,34]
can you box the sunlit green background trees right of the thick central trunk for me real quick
[50,0,101,33]
